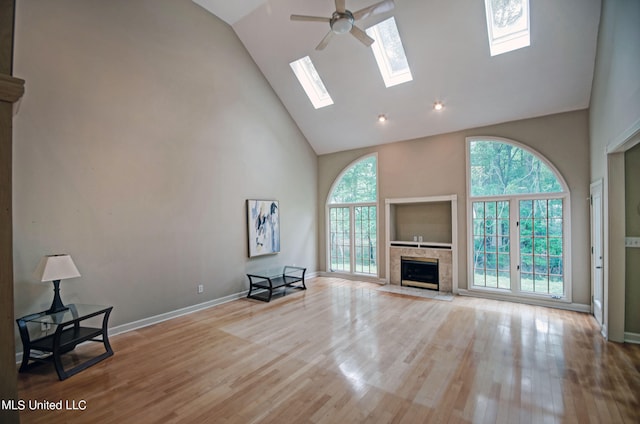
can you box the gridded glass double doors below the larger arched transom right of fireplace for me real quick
[472,197,566,298]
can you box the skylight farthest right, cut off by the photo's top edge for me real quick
[484,0,531,56]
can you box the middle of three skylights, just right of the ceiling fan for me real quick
[367,16,413,87]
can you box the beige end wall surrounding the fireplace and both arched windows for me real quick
[318,111,591,305]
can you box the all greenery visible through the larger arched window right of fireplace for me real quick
[470,141,564,295]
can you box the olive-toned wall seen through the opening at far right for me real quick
[624,144,640,334]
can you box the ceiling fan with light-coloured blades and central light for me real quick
[291,0,395,50]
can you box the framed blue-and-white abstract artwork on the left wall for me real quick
[247,199,280,258]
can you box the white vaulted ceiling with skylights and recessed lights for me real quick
[193,0,601,154]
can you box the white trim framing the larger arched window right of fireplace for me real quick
[465,136,573,303]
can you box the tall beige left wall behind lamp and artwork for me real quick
[14,0,317,338]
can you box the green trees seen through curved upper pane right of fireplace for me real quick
[470,141,563,196]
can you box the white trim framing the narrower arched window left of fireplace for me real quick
[324,153,380,277]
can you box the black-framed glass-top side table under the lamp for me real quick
[16,304,113,380]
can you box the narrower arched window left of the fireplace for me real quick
[327,155,378,275]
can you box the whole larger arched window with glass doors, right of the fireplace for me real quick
[467,138,571,301]
